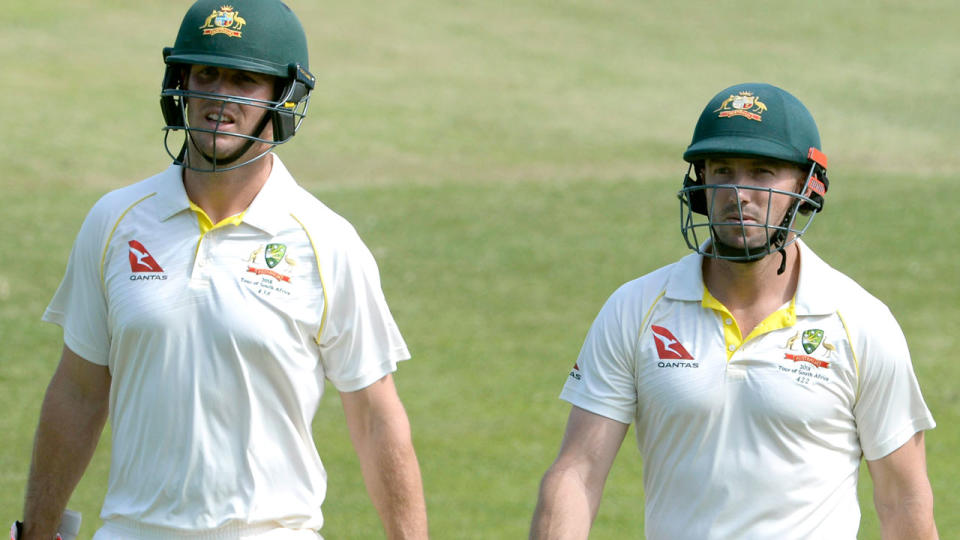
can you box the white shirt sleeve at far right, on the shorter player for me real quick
[854,308,936,460]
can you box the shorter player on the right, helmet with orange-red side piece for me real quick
[531,84,937,539]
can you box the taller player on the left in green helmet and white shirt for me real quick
[15,0,427,540]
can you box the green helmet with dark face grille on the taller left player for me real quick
[160,0,316,172]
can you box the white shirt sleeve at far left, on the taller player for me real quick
[43,204,110,366]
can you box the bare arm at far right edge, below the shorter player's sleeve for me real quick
[867,431,938,540]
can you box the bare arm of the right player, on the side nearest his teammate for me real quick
[530,406,629,540]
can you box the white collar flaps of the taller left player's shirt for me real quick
[155,153,296,235]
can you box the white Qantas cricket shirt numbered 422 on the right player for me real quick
[561,242,935,540]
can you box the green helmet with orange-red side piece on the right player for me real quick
[677,83,829,271]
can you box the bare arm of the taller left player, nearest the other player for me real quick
[340,375,427,539]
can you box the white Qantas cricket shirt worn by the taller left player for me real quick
[44,155,410,530]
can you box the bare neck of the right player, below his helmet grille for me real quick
[703,243,800,316]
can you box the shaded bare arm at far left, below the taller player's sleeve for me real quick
[23,346,111,540]
